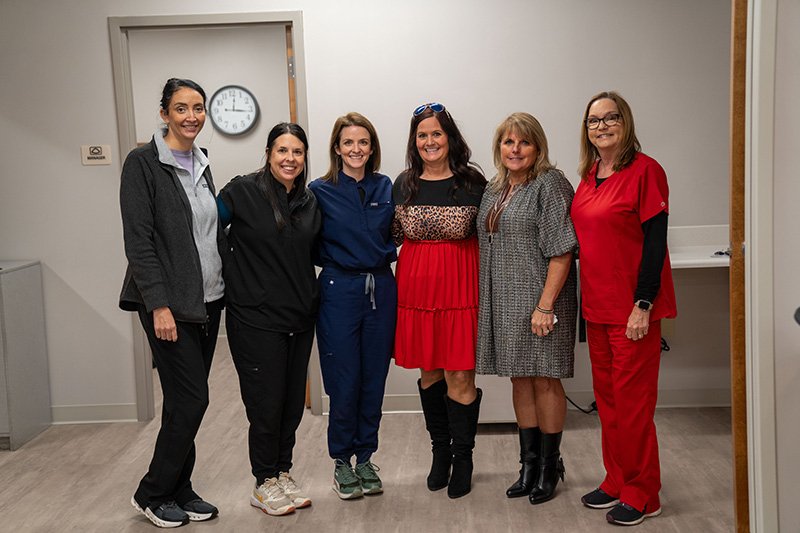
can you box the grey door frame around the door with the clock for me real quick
[108,11,312,421]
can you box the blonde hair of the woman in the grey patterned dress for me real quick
[489,112,555,191]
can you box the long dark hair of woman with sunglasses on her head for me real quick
[400,107,486,205]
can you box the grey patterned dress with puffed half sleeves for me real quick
[476,169,578,378]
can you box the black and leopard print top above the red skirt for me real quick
[392,175,483,246]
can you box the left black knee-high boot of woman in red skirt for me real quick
[417,379,453,490]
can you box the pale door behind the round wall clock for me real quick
[128,24,291,189]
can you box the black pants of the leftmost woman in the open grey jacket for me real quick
[134,300,223,508]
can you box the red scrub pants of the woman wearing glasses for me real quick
[586,320,661,513]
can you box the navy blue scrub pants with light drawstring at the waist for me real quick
[317,267,397,464]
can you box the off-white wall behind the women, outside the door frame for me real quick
[0,0,730,420]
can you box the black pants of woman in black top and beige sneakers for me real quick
[225,313,314,483]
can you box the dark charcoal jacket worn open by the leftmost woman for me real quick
[119,139,228,323]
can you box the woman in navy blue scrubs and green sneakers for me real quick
[309,113,397,499]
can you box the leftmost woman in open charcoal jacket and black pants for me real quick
[119,78,226,527]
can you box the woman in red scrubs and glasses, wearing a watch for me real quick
[571,92,676,525]
